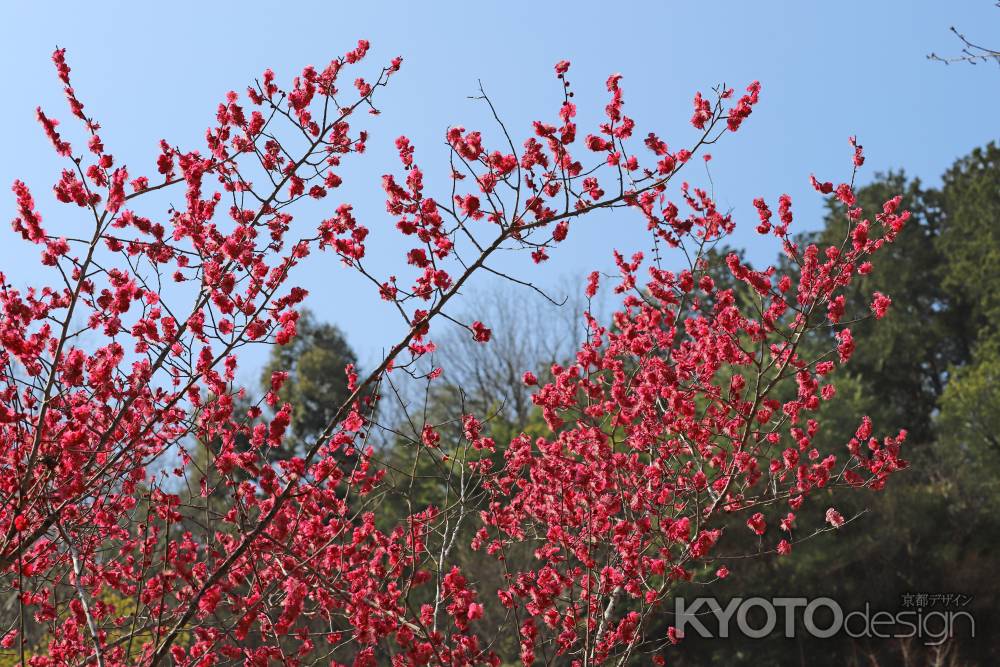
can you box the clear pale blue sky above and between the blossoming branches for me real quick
[0,0,1000,380]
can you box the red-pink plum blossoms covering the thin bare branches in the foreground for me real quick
[0,41,908,667]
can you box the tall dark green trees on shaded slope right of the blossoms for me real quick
[660,153,1000,667]
